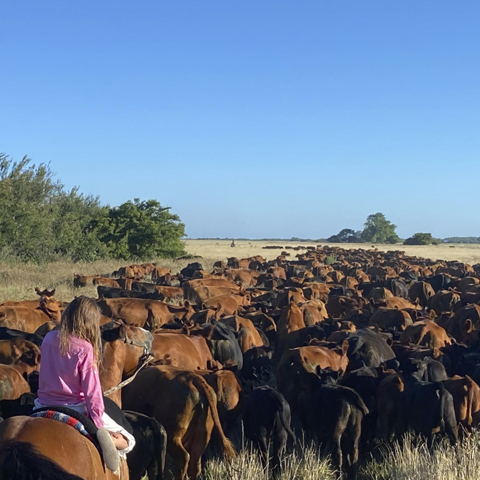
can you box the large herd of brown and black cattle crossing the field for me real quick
[0,246,480,480]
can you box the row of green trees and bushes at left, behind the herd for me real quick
[0,154,185,262]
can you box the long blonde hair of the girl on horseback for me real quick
[60,295,102,365]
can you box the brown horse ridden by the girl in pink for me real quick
[0,322,152,480]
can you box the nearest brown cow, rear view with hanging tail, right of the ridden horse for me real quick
[122,366,235,480]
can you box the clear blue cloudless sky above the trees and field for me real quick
[0,0,480,238]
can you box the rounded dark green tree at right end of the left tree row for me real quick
[99,198,185,259]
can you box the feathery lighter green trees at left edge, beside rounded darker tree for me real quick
[0,154,107,262]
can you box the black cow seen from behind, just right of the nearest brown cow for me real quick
[243,386,295,470]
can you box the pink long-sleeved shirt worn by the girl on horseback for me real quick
[38,330,105,428]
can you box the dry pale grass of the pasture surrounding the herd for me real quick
[0,240,480,480]
